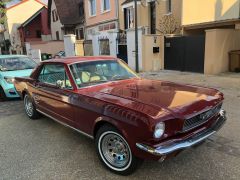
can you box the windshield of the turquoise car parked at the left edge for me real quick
[0,57,37,71]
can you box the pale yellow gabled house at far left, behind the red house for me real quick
[4,0,45,54]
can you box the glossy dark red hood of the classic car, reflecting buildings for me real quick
[88,79,223,118]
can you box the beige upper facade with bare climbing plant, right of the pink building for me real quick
[119,0,182,34]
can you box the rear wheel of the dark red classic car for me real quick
[24,94,39,119]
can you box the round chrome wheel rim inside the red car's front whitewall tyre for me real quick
[101,134,130,168]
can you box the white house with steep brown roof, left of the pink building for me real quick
[48,0,85,40]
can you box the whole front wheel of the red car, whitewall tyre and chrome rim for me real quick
[95,126,142,175]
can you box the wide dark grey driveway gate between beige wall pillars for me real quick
[164,36,205,73]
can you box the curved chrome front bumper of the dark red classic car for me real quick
[136,110,227,156]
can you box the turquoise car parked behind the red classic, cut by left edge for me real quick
[0,55,37,100]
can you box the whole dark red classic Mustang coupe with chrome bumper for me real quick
[14,57,226,175]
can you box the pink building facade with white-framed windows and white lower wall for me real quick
[85,0,119,56]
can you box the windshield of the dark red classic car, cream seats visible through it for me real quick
[70,60,138,88]
